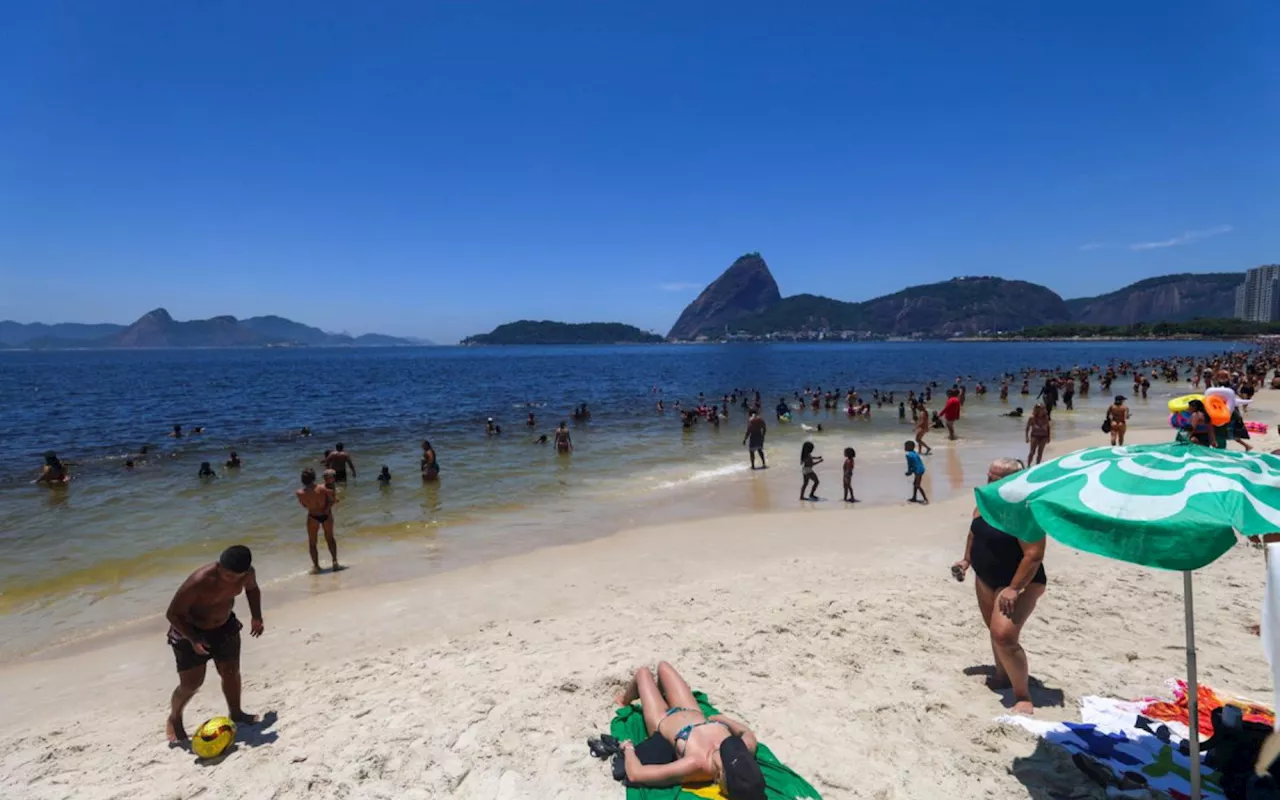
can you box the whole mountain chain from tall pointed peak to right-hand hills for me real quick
[667,252,1244,342]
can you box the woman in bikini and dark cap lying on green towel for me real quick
[614,662,764,800]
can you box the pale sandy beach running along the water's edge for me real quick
[0,394,1280,800]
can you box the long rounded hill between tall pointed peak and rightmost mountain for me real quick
[736,276,1070,337]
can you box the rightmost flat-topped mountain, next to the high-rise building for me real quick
[1066,273,1244,325]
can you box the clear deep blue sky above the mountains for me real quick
[0,0,1280,342]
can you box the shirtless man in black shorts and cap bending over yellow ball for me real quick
[165,544,264,744]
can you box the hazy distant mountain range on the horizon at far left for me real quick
[0,308,430,349]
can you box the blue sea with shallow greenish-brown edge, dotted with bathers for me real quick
[0,342,1231,657]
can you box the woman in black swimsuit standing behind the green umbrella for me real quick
[951,458,1046,714]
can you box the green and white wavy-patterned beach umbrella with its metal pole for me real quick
[974,443,1280,799]
